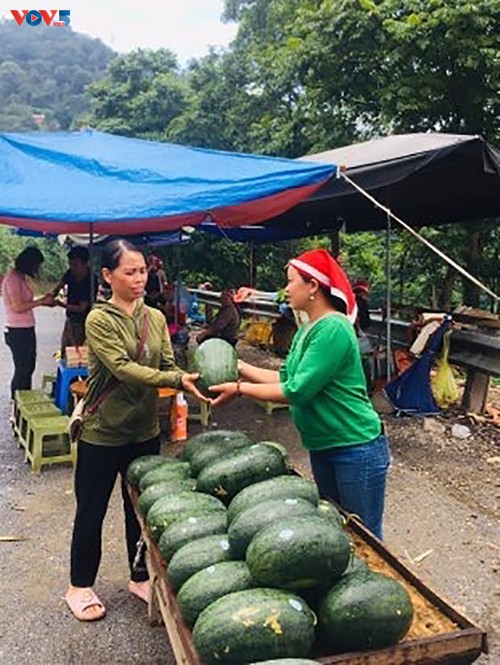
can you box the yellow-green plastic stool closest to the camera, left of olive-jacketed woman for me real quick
[26,416,76,473]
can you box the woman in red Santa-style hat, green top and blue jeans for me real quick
[210,249,390,538]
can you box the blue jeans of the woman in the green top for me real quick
[309,434,391,540]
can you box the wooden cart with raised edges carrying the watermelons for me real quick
[130,488,487,665]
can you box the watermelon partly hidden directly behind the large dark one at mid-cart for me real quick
[227,499,316,556]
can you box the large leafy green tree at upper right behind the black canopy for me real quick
[225,0,500,305]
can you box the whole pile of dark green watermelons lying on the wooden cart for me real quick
[127,430,413,665]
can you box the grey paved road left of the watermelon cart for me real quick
[0,308,175,665]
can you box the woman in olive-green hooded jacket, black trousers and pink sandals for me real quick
[65,240,207,621]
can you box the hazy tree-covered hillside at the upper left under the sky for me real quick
[0,20,115,132]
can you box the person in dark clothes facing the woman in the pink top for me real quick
[52,247,95,358]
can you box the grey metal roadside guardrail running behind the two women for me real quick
[190,289,500,376]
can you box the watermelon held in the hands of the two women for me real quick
[193,338,238,397]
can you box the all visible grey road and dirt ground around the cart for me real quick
[0,308,500,665]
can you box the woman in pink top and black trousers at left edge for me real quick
[2,247,54,399]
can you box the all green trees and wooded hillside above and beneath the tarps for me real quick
[0,0,500,308]
